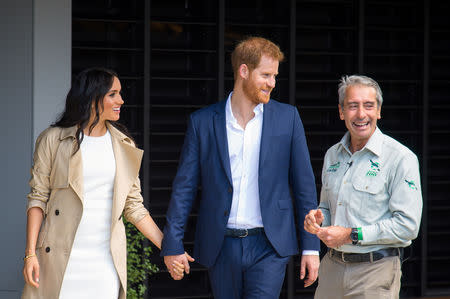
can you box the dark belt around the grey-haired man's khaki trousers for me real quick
[328,247,403,263]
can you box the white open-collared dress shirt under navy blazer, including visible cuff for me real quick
[225,93,319,255]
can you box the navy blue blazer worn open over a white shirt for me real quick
[161,100,319,267]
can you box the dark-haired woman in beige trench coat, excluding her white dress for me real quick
[22,68,192,299]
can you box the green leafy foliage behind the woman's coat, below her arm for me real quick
[124,219,159,299]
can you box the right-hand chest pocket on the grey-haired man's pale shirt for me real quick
[352,174,389,221]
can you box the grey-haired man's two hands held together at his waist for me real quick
[303,209,352,248]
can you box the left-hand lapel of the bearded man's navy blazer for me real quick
[214,101,232,183]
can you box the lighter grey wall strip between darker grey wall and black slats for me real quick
[33,0,72,140]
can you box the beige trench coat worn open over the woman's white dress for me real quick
[22,123,148,299]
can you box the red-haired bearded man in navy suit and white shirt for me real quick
[161,37,319,299]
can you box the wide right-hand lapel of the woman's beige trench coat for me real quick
[107,123,144,230]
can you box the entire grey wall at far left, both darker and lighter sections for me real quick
[0,0,72,299]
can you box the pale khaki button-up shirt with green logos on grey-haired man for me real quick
[319,128,422,253]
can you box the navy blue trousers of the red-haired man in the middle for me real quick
[209,233,289,299]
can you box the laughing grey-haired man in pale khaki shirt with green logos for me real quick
[304,75,422,299]
